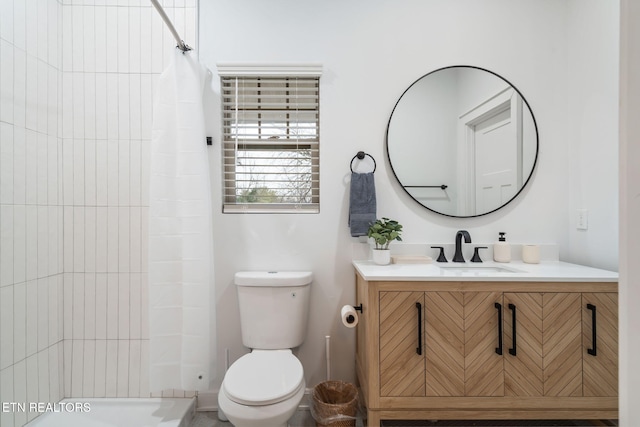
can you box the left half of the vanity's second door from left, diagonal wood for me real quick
[424,292,464,396]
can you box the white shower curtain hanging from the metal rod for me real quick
[149,49,215,392]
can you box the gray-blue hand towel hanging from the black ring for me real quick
[349,172,376,237]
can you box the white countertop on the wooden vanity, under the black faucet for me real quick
[353,260,618,282]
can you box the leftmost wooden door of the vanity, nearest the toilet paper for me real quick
[380,291,425,396]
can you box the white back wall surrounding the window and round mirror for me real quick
[200,0,617,392]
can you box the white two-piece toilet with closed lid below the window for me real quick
[218,271,313,427]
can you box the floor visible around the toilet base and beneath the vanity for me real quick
[189,410,618,427]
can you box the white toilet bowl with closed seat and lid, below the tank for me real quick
[218,349,306,427]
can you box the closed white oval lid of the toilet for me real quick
[224,350,304,406]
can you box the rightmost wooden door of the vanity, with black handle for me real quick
[582,293,618,396]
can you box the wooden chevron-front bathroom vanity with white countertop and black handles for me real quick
[353,261,618,426]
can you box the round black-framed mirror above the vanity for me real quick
[387,66,538,217]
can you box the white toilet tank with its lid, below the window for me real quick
[235,271,313,350]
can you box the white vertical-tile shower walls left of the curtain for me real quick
[0,0,197,426]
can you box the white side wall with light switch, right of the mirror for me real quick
[565,0,620,270]
